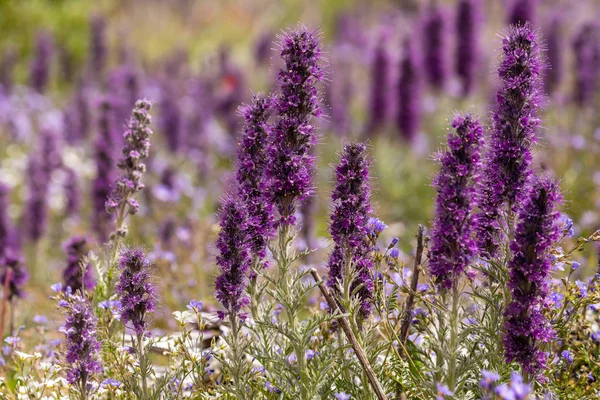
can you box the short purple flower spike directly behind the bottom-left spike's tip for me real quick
[63,236,96,292]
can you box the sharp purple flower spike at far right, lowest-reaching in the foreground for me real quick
[504,178,561,375]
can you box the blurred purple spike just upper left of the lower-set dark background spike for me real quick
[367,32,392,133]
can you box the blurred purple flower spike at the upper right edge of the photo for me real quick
[573,22,600,107]
